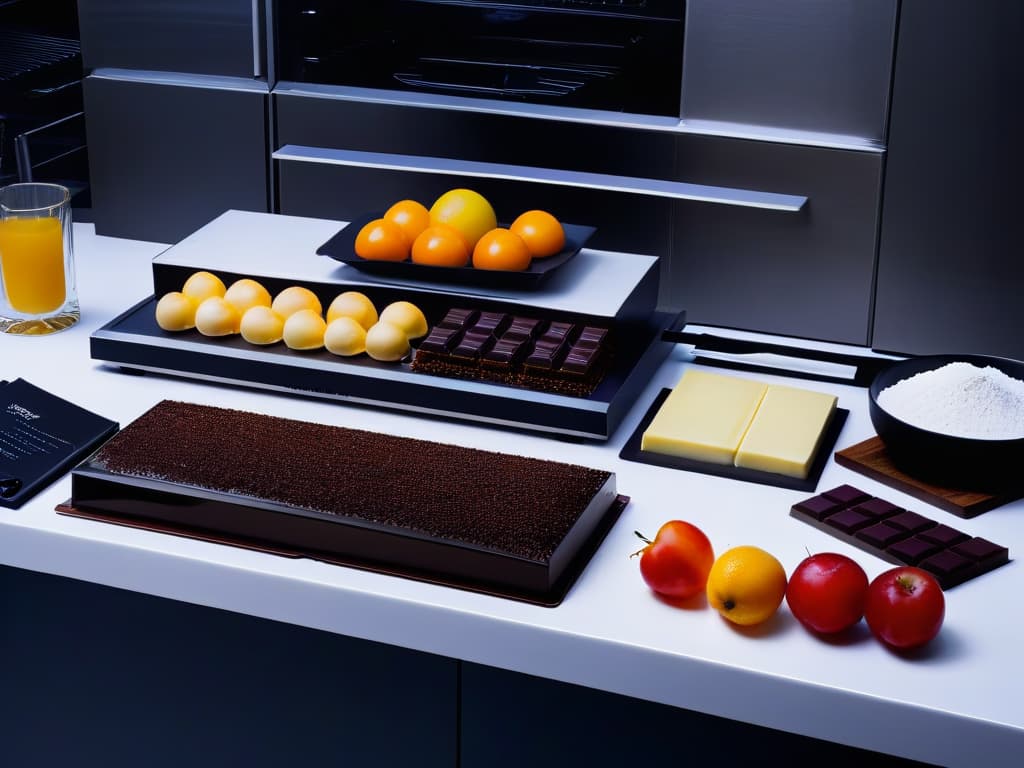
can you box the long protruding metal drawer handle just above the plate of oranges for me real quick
[272,144,807,212]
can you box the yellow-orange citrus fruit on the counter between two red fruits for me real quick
[708,546,786,626]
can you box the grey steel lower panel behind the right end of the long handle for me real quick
[668,136,883,344]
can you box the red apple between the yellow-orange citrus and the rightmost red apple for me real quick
[785,552,867,634]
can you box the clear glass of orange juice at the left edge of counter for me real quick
[0,182,80,336]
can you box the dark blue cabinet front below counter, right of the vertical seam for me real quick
[459,662,921,768]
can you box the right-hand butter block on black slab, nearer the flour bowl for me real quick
[735,384,837,478]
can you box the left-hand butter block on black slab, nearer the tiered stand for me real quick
[640,369,768,464]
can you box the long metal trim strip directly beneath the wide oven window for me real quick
[271,80,885,153]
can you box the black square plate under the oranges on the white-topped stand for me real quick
[316,213,596,291]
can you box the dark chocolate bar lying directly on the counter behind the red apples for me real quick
[790,485,1010,590]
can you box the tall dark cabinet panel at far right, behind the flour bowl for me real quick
[872,0,1024,358]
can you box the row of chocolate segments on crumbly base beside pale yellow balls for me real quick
[413,308,610,397]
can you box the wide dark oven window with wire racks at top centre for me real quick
[278,0,686,116]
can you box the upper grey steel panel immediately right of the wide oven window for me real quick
[682,0,898,142]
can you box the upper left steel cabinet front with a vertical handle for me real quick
[79,0,262,78]
